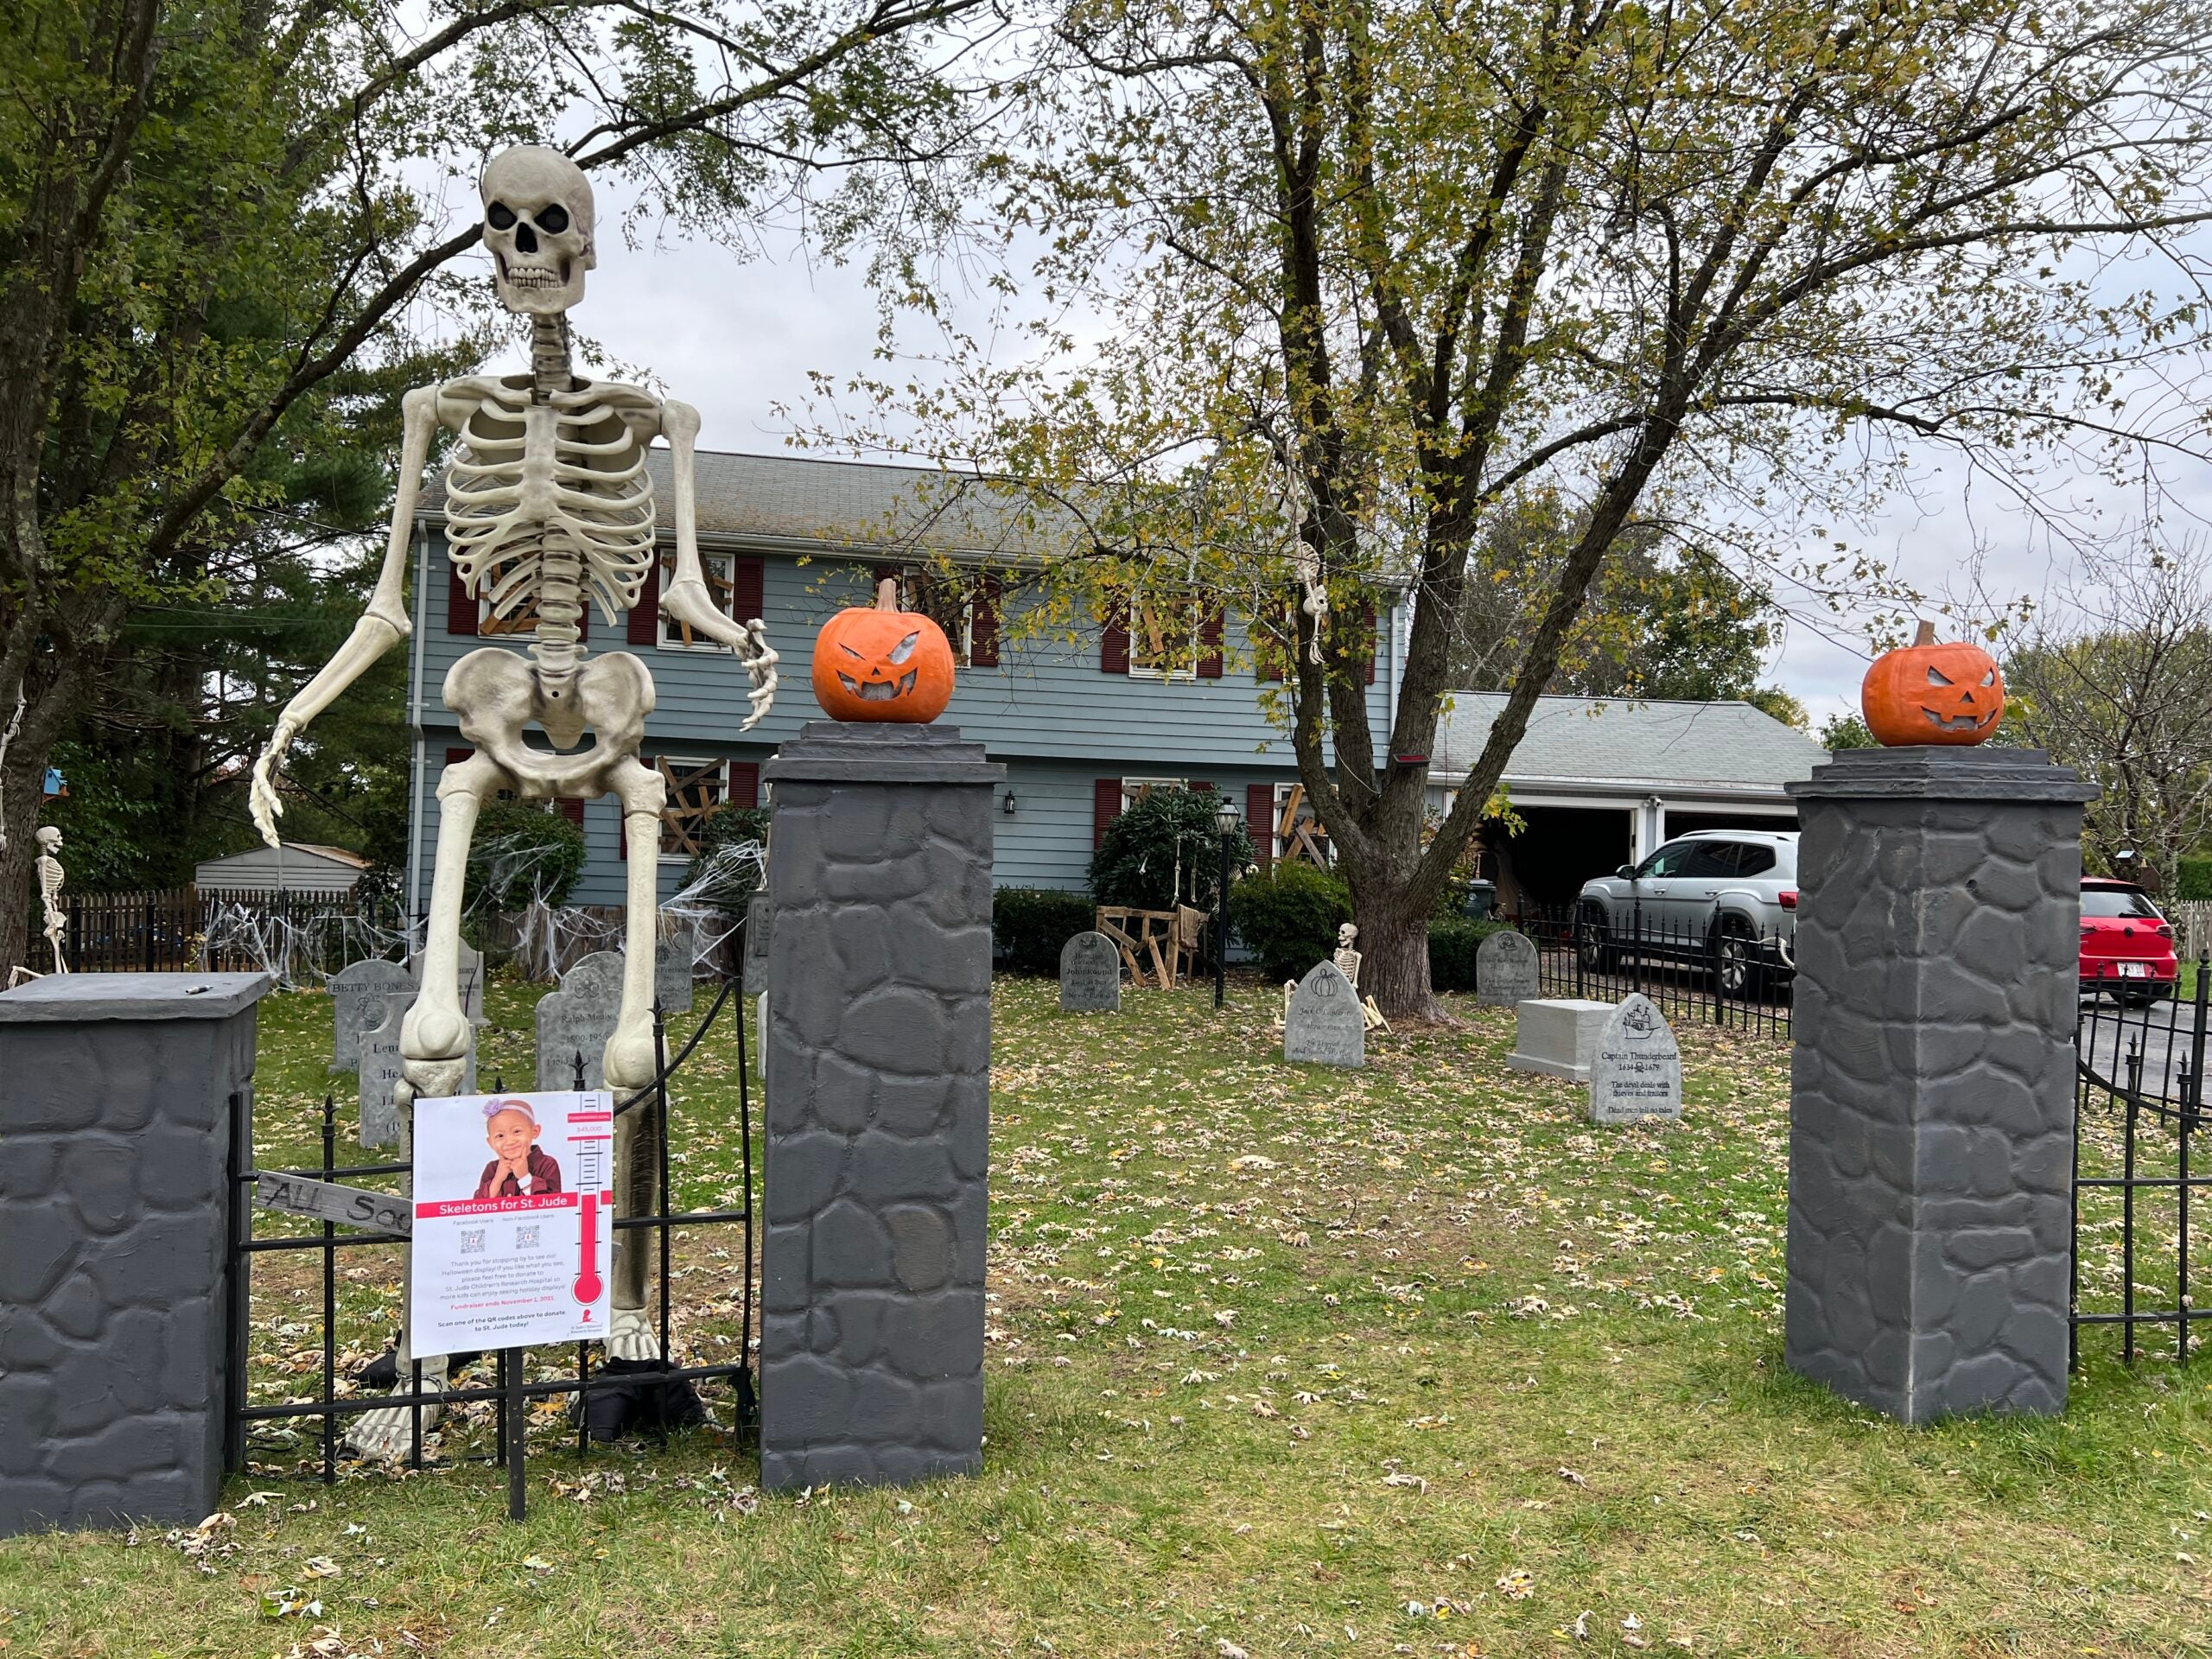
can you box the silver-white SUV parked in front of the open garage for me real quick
[1575,830,1798,995]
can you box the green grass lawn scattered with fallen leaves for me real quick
[0,980,2212,1659]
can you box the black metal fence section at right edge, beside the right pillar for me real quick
[2070,957,2212,1365]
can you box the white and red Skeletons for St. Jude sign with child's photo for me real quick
[407,1089,615,1354]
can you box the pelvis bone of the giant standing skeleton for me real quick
[445,646,652,801]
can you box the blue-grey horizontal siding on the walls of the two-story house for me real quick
[411,522,1394,907]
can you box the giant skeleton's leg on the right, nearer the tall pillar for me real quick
[606,757,668,1360]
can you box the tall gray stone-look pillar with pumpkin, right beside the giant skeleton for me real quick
[761,721,1004,1491]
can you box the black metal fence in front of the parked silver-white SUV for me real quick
[1510,905,1796,1038]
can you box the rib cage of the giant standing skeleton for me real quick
[445,383,652,666]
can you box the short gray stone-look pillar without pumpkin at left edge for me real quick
[0,973,270,1537]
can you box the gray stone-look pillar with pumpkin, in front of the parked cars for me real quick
[1785,747,2094,1422]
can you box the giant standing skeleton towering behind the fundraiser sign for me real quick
[252,146,777,1458]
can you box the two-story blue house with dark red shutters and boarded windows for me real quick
[407,451,1405,916]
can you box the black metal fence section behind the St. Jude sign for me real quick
[224,940,754,1520]
